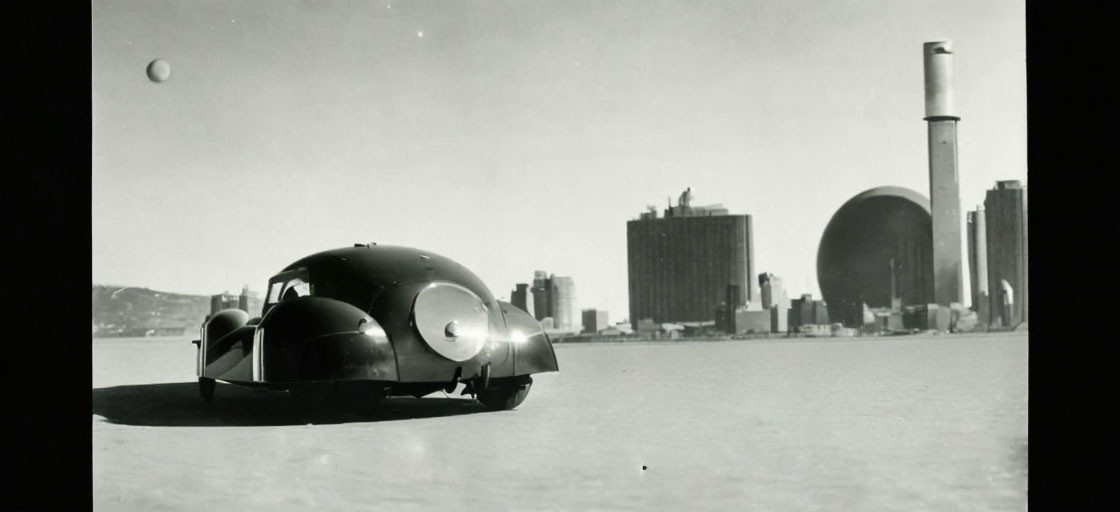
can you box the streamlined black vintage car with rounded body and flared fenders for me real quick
[194,244,559,410]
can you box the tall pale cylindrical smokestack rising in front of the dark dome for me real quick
[922,40,964,306]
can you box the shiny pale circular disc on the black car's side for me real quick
[412,282,489,362]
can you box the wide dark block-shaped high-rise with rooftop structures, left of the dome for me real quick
[626,189,758,328]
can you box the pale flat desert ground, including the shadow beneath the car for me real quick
[93,333,1028,512]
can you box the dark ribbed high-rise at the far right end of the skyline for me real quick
[983,180,1029,326]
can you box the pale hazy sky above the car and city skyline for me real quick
[91,0,1027,322]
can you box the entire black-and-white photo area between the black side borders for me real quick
[91,0,1029,512]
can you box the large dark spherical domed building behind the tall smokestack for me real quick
[816,187,933,327]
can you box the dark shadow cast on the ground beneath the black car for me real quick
[93,382,486,427]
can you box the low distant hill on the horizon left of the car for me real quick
[93,285,261,337]
